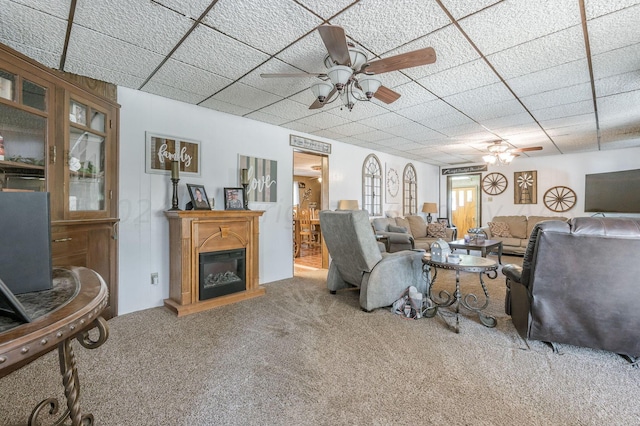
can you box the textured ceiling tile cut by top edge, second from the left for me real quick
[74,0,193,55]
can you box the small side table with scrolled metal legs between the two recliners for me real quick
[422,255,498,333]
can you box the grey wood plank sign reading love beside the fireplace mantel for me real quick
[238,155,278,203]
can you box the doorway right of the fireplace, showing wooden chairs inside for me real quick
[292,150,329,275]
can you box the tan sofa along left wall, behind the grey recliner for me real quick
[371,215,456,253]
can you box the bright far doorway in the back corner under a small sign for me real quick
[447,174,482,233]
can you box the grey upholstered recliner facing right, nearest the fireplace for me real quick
[320,210,428,311]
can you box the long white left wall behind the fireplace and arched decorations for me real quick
[118,88,439,314]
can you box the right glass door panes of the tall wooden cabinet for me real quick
[68,99,106,211]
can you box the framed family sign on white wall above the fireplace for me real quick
[145,132,200,177]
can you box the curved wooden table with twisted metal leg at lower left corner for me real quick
[0,267,109,426]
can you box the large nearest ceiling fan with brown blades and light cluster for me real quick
[260,25,436,111]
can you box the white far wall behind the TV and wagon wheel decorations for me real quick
[440,148,640,226]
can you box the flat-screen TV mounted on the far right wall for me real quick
[584,169,640,213]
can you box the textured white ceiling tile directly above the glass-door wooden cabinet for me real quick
[65,25,163,85]
